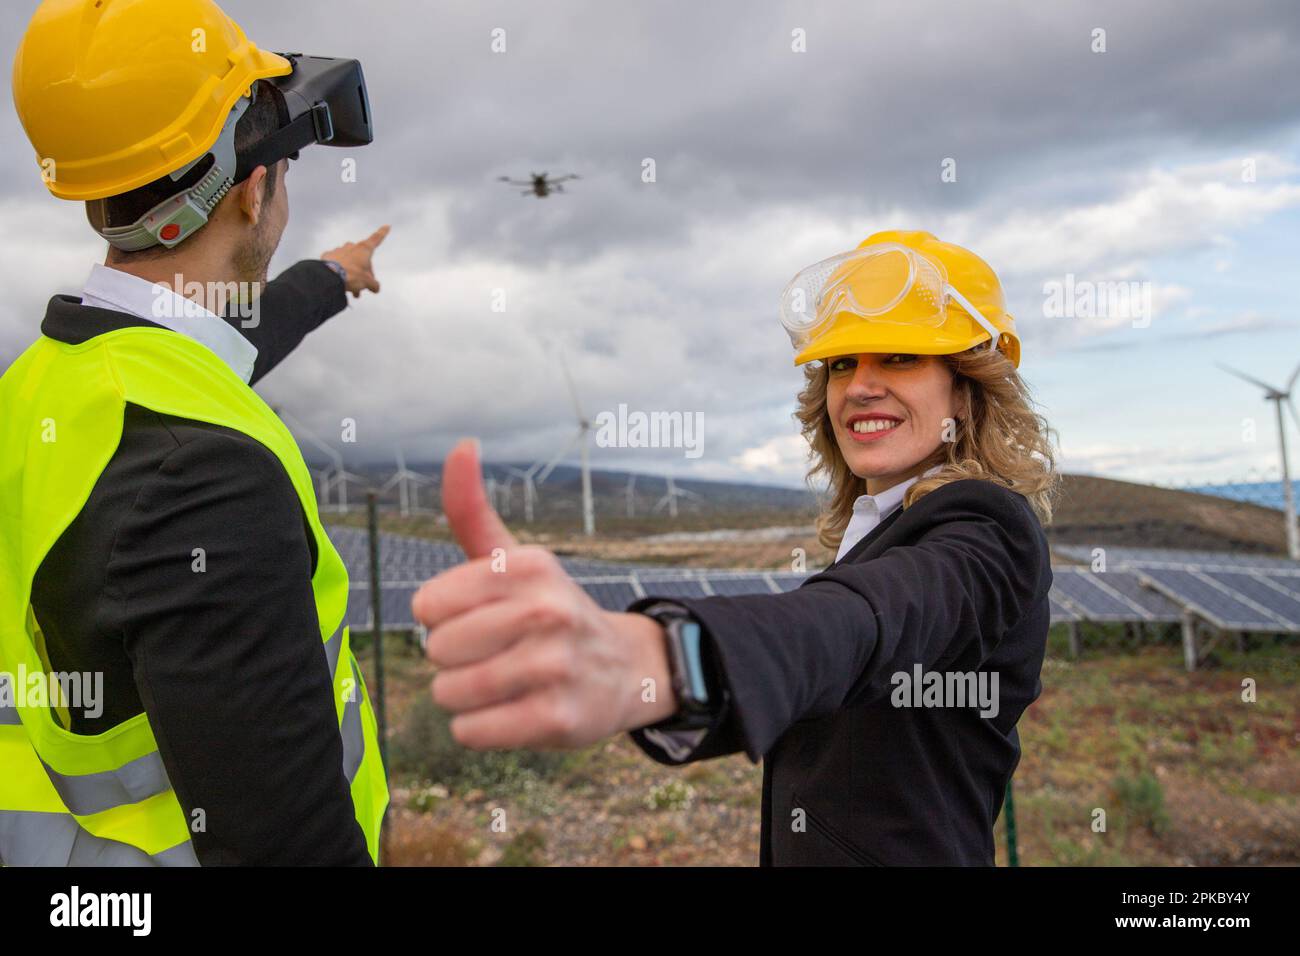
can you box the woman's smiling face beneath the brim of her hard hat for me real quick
[826,352,959,494]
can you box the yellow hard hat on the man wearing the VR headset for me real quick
[13,0,294,200]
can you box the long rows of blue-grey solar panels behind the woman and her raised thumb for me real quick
[328,525,1300,632]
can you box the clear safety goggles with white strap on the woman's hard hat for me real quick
[781,242,1001,351]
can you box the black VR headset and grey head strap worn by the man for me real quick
[86,53,374,252]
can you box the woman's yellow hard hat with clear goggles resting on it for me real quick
[781,230,1021,367]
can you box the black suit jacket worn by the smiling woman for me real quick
[632,479,1052,865]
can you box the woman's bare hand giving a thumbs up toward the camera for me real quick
[411,441,677,749]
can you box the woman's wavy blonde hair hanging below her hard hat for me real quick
[794,343,1061,550]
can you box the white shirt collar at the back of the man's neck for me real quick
[82,263,257,382]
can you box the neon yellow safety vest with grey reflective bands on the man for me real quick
[0,326,389,866]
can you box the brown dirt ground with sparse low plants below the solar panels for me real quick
[367,633,1300,866]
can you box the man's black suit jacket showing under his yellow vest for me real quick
[31,260,371,866]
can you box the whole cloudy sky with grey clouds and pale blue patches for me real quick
[0,0,1300,485]
